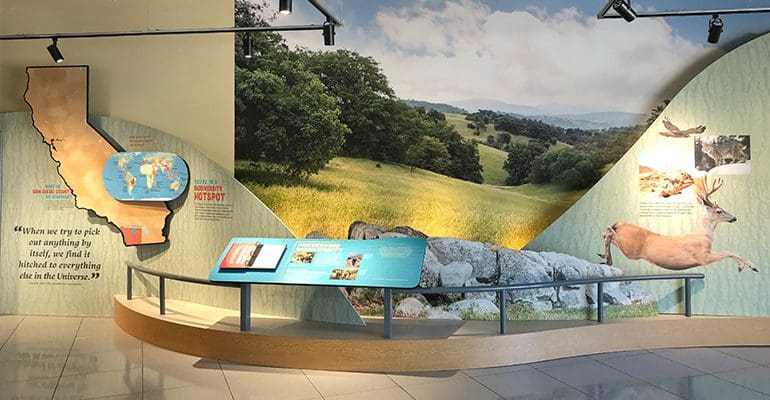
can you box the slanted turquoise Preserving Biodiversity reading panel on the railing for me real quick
[209,238,427,288]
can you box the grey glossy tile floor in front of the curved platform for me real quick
[0,315,770,400]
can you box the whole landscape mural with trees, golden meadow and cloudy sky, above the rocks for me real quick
[236,0,770,248]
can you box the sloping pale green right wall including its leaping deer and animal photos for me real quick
[527,35,770,316]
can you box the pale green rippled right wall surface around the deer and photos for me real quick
[526,35,770,316]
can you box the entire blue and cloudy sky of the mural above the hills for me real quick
[273,0,770,113]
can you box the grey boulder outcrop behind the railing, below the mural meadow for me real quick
[348,221,655,319]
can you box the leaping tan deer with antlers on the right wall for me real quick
[599,177,759,272]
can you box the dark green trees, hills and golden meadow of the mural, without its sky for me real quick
[235,0,648,248]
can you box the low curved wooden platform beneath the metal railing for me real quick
[114,295,770,372]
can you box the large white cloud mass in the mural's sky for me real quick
[282,0,716,112]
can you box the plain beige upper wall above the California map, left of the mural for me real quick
[0,0,234,173]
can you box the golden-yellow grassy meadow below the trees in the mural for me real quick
[236,157,584,248]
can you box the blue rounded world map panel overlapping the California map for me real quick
[102,151,190,201]
